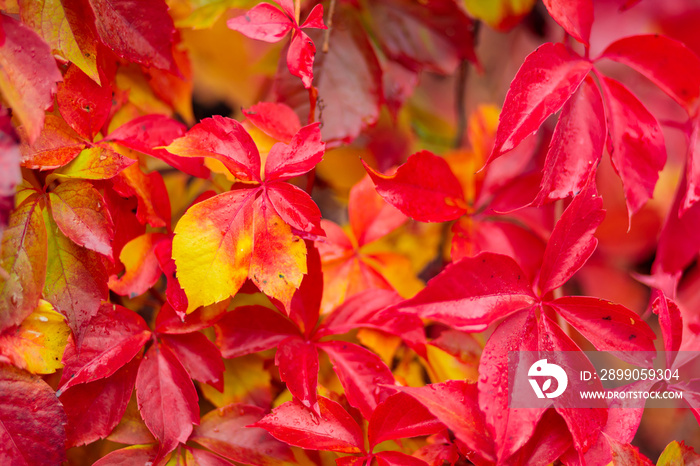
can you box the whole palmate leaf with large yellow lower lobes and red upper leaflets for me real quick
[168,117,325,312]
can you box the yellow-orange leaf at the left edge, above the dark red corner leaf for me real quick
[0,300,70,374]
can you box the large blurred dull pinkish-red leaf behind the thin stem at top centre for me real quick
[274,3,383,145]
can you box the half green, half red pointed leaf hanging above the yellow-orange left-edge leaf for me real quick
[44,212,109,345]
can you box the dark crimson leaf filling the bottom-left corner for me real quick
[0,364,66,465]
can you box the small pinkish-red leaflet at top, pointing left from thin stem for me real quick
[226,3,295,42]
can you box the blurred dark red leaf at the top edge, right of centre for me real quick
[370,0,476,74]
